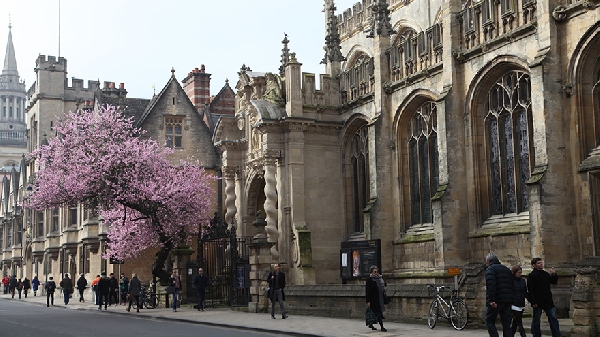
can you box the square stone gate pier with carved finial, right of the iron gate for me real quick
[248,211,273,312]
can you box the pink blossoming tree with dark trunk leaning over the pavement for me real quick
[25,106,215,279]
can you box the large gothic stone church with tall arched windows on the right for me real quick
[215,0,600,318]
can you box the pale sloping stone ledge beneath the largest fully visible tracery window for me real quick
[469,212,530,238]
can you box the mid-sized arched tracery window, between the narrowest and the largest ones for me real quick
[407,101,439,226]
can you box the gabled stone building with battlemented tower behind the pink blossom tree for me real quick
[0,52,234,294]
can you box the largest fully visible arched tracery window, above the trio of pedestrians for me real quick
[485,70,533,215]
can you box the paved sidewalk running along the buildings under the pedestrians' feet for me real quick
[0,293,573,337]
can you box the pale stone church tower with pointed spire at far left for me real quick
[0,24,27,173]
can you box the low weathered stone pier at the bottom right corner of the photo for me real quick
[571,257,600,337]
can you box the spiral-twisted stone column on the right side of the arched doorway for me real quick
[264,159,279,260]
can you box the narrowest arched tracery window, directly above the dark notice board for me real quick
[350,125,369,233]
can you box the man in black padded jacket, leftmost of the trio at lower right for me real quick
[485,253,514,337]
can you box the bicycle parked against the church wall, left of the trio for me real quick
[427,284,469,330]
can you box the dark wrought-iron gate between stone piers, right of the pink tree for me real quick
[194,214,251,307]
